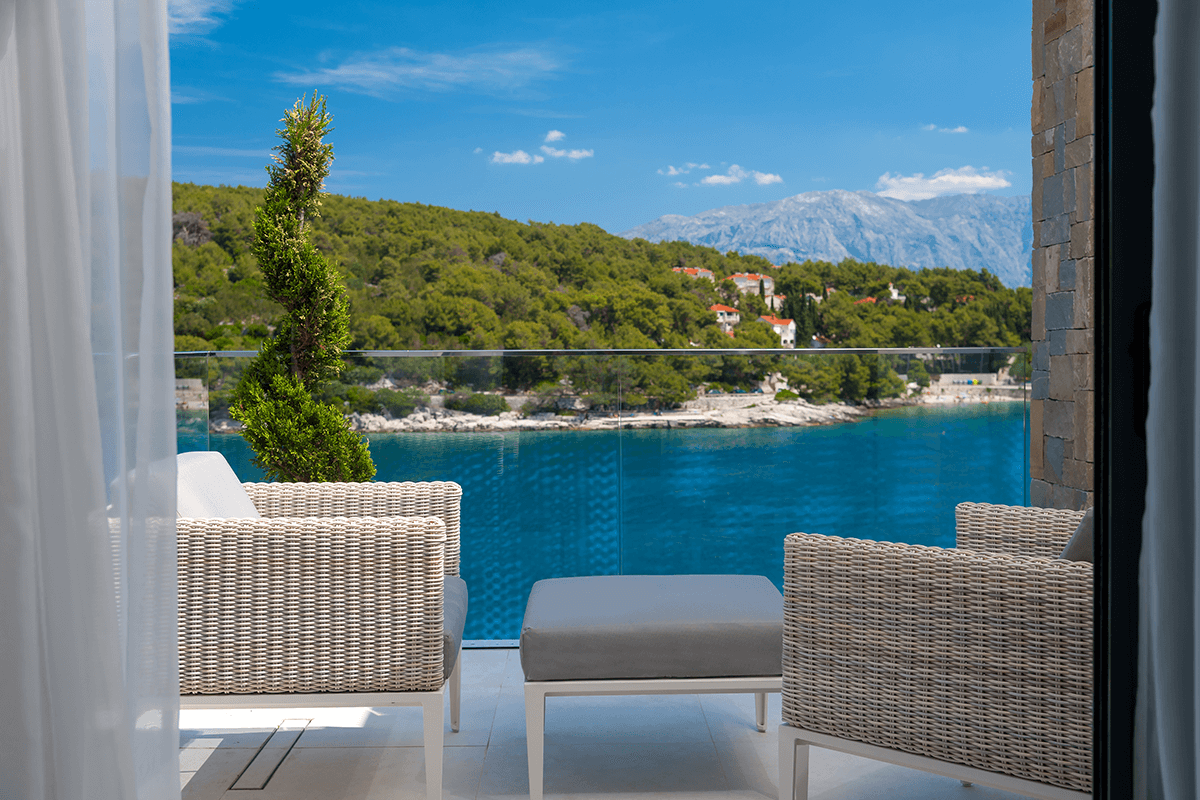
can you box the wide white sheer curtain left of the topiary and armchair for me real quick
[0,0,179,800]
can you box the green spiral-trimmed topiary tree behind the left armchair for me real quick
[229,92,376,481]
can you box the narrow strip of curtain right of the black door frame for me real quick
[1135,0,1200,800]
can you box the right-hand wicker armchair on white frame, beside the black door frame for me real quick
[779,503,1092,800]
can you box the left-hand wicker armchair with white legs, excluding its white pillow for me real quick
[176,460,466,799]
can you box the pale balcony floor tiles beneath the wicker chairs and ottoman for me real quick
[180,650,1032,800]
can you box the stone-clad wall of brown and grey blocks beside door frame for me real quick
[1030,0,1096,509]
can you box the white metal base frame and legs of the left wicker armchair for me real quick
[179,648,462,800]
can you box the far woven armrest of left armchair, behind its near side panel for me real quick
[242,481,462,575]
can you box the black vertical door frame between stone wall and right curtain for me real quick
[1094,0,1158,800]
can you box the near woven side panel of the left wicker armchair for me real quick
[176,517,446,694]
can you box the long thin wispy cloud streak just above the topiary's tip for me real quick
[274,47,560,96]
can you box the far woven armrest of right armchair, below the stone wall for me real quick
[954,503,1084,558]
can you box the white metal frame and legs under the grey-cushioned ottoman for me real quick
[524,675,784,800]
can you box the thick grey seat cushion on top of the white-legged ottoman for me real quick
[521,575,784,680]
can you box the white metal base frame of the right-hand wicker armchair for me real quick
[779,723,1092,800]
